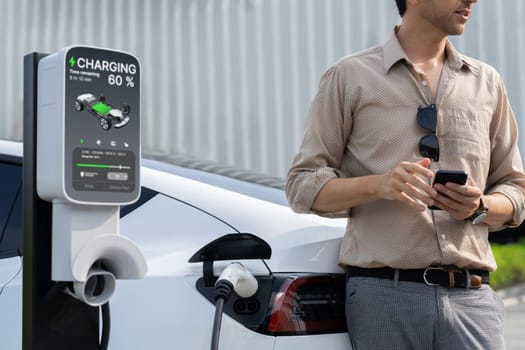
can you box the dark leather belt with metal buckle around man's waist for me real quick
[346,266,490,289]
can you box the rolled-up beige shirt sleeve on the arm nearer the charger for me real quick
[286,67,352,216]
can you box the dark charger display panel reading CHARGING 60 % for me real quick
[64,47,140,203]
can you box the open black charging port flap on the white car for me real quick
[188,233,272,286]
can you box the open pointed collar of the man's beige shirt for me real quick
[383,26,479,74]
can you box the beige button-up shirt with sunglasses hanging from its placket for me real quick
[286,30,525,271]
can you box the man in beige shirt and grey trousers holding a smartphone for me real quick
[287,0,525,350]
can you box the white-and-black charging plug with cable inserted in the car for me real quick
[211,262,258,350]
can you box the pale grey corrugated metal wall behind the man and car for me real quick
[0,0,525,177]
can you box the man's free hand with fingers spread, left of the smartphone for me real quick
[381,158,437,211]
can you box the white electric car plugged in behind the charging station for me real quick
[0,141,350,350]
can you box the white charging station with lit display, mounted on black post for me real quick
[24,46,147,349]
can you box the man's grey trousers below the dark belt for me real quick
[346,277,505,350]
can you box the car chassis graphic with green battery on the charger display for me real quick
[75,93,130,130]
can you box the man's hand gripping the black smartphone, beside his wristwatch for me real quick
[433,177,483,220]
